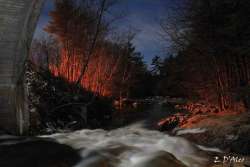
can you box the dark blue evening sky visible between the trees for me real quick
[35,0,171,64]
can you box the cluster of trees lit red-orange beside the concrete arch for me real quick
[41,0,147,98]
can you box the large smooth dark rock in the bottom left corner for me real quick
[0,139,80,167]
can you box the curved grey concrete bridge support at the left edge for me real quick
[0,0,43,134]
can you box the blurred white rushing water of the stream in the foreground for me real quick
[42,123,216,167]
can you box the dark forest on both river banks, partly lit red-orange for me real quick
[27,0,250,133]
